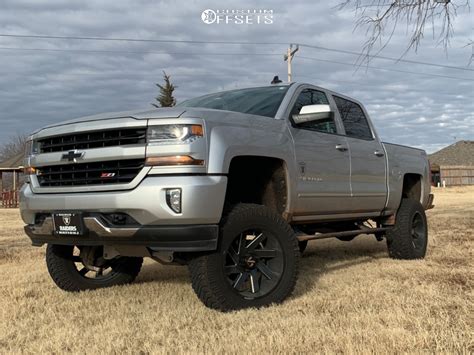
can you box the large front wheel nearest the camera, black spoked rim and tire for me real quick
[189,204,300,311]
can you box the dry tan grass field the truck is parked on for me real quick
[0,187,474,353]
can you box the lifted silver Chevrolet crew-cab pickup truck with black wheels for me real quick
[21,83,433,311]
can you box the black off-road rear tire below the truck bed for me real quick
[386,198,428,260]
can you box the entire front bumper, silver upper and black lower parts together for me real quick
[20,175,227,251]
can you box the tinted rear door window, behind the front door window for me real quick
[334,96,373,139]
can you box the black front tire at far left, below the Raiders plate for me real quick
[46,244,143,292]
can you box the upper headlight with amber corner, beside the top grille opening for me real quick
[147,124,204,144]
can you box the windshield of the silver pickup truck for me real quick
[178,85,289,117]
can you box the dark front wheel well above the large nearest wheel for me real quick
[225,156,288,214]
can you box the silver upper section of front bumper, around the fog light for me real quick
[20,175,227,226]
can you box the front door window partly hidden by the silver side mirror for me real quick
[291,89,337,133]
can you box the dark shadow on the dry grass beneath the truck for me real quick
[136,237,388,297]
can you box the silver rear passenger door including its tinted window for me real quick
[333,95,387,213]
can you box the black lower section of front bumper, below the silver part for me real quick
[25,217,219,252]
